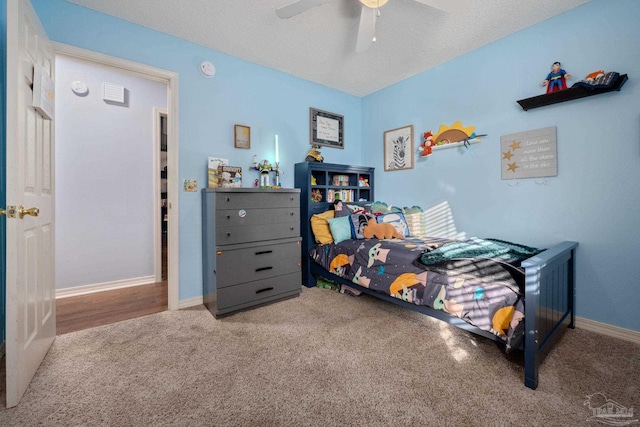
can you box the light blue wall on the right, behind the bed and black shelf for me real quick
[362,0,640,331]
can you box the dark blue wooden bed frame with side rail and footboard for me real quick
[301,200,578,390]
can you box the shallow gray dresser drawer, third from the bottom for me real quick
[216,221,300,246]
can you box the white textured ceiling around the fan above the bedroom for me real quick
[67,0,589,96]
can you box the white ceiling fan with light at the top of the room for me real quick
[276,0,468,53]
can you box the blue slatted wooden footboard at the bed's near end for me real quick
[522,241,578,389]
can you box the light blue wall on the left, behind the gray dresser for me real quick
[32,0,362,300]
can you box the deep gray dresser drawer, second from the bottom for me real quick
[215,240,301,290]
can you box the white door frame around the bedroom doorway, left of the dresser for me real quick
[52,42,180,310]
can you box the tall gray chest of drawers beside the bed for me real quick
[202,188,302,318]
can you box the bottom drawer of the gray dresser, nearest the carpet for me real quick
[217,271,302,314]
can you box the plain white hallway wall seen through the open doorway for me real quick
[55,56,167,289]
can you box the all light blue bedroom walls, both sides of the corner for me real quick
[26,0,640,330]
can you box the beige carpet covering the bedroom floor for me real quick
[0,288,640,426]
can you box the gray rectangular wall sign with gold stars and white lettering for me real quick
[500,126,558,179]
